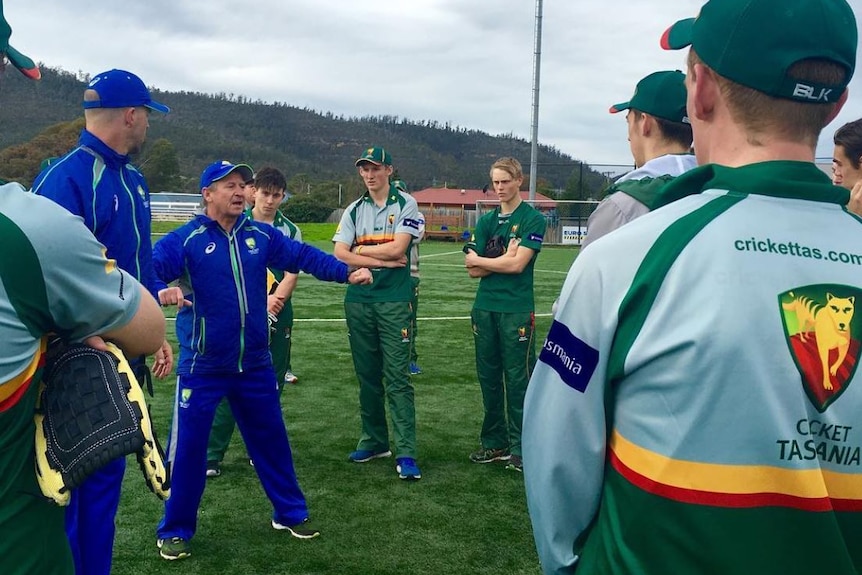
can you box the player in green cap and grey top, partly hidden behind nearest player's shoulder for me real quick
[581,70,697,249]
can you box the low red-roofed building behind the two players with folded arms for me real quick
[410,188,557,239]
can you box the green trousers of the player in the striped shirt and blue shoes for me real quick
[344,301,416,459]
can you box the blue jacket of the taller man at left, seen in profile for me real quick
[33,130,157,295]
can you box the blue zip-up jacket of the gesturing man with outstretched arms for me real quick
[153,214,349,375]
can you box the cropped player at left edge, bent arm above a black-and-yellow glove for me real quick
[0,14,165,575]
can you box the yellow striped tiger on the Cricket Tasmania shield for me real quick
[781,292,856,390]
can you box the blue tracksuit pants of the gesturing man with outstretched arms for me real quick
[156,366,308,540]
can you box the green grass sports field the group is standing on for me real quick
[113,223,576,575]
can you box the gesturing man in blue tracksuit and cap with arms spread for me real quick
[153,162,372,560]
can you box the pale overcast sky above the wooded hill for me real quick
[5,0,862,169]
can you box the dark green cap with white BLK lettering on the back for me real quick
[661,0,858,103]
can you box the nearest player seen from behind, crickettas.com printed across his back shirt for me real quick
[524,0,862,575]
